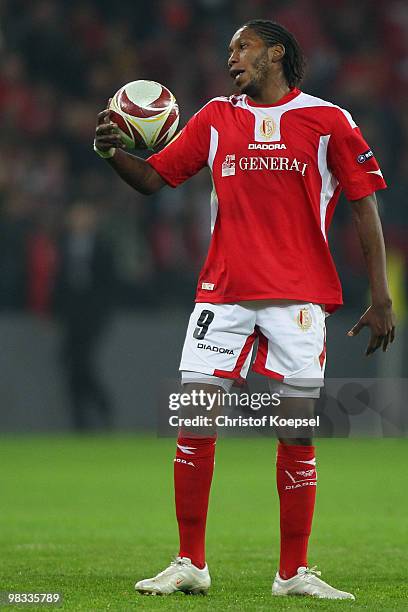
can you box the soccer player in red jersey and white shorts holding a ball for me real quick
[94,19,395,599]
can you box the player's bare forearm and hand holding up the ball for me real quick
[94,110,166,195]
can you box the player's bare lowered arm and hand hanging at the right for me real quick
[348,193,395,355]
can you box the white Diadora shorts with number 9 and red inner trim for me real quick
[180,300,326,387]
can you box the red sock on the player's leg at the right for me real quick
[276,443,317,580]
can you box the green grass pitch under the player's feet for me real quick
[0,435,408,612]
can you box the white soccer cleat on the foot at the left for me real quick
[135,557,211,595]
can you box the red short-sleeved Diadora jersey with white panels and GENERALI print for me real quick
[147,89,386,312]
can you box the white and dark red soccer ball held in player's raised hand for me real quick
[109,81,180,150]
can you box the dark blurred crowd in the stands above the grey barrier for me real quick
[0,0,408,430]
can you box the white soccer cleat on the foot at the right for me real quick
[272,567,355,600]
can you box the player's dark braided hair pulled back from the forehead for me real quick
[243,19,306,87]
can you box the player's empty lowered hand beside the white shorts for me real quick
[347,303,395,355]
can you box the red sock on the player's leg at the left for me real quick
[174,436,216,569]
